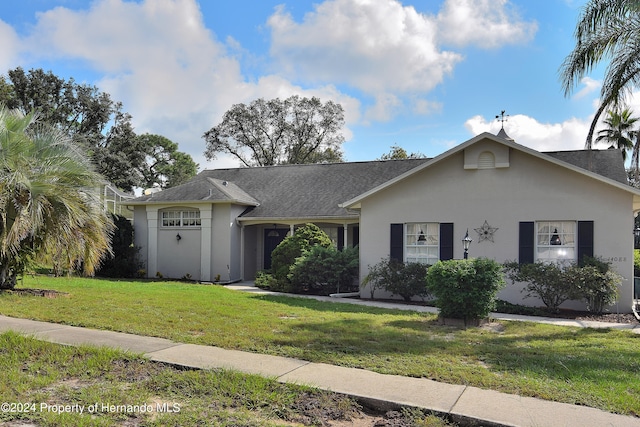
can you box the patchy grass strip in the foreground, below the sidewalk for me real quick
[0,332,450,427]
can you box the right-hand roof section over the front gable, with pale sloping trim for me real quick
[340,132,640,211]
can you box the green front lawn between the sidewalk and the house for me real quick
[0,277,640,416]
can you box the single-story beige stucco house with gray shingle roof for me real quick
[127,130,640,312]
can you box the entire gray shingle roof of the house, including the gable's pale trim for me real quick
[128,133,640,221]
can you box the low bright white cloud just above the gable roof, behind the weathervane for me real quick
[465,114,595,151]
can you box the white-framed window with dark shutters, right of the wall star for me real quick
[536,221,577,262]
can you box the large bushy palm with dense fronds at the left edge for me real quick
[0,108,113,289]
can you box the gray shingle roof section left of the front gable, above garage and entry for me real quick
[134,159,427,218]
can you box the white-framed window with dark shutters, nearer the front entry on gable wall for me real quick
[405,222,440,265]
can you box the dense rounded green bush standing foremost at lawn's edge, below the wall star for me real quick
[427,258,504,322]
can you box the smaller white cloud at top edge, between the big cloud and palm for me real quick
[437,0,538,48]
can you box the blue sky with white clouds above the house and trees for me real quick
[0,0,640,169]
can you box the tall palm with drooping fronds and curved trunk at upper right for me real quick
[560,0,640,149]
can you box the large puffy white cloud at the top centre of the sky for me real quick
[268,0,462,94]
